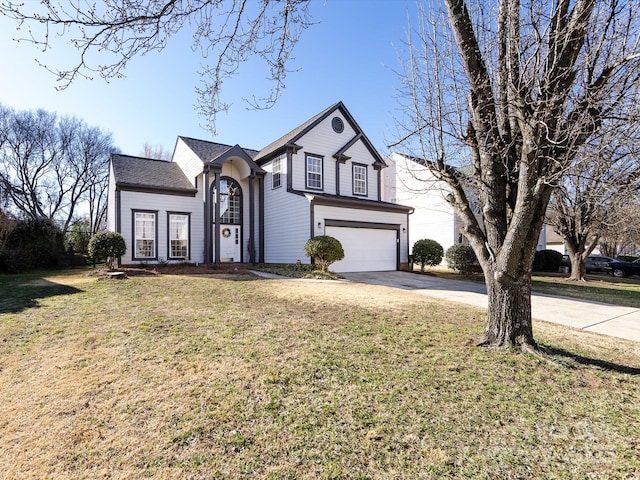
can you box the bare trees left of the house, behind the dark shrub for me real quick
[0,107,114,233]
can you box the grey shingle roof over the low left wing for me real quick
[111,153,197,195]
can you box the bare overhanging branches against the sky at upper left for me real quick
[0,0,311,132]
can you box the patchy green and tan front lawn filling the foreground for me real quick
[0,272,640,479]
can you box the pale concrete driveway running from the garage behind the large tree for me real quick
[341,272,640,342]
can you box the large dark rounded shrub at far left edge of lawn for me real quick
[0,217,64,272]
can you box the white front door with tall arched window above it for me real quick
[212,177,243,262]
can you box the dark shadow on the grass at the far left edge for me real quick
[0,276,82,314]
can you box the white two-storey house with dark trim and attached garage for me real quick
[108,102,412,272]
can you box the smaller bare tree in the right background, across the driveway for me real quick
[546,126,640,281]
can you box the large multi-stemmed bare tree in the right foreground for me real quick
[392,0,640,351]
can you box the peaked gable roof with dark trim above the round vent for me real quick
[254,102,387,168]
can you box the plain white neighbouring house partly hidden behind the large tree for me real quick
[383,153,546,258]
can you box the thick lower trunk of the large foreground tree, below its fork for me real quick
[479,274,536,350]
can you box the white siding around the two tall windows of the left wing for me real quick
[120,191,204,265]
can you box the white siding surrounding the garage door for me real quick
[313,205,409,263]
